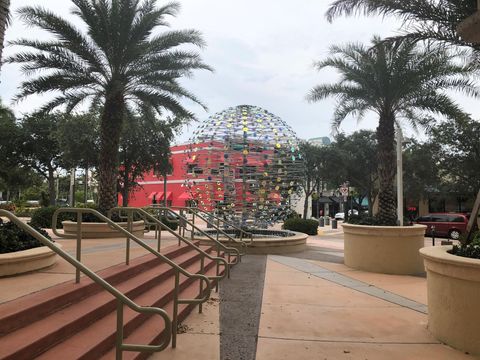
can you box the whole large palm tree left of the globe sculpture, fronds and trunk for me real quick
[7,0,211,212]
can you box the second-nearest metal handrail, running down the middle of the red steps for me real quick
[52,208,212,348]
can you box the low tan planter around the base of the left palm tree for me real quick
[62,220,145,239]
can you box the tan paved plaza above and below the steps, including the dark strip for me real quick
[0,224,474,360]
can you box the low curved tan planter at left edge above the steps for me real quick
[0,243,61,277]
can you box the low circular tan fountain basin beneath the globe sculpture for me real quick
[194,229,308,254]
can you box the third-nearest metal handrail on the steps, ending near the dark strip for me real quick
[108,207,230,286]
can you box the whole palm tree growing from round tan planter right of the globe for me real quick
[307,38,476,225]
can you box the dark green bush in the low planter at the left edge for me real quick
[0,219,52,254]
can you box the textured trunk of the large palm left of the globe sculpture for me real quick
[98,95,125,214]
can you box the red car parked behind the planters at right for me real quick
[415,213,468,240]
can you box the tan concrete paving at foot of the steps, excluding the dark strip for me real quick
[157,229,475,360]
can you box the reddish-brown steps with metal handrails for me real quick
[0,243,224,360]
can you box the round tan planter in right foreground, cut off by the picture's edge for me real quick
[420,246,480,356]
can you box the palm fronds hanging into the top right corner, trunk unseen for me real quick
[326,0,480,50]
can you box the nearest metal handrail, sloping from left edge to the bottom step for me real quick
[0,209,172,360]
